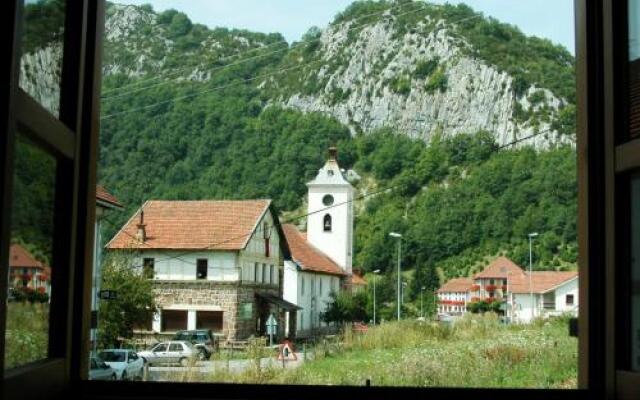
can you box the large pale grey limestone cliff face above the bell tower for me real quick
[278,17,572,147]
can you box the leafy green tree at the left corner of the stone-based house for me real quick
[98,252,157,347]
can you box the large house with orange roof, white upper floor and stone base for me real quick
[107,200,298,341]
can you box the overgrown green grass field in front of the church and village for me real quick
[201,315,578,389]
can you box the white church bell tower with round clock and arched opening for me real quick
[307,147,354,275]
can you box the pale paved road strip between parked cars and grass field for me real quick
[147,353,309,381]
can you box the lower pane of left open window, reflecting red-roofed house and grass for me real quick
[5,136,56,368]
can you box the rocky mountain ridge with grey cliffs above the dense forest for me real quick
[99,1,573,146]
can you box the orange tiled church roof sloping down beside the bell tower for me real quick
[282,224,346,275]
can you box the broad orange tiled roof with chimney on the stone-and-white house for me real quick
[107,200,271,250]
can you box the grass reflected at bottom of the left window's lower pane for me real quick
[4,302,49,369]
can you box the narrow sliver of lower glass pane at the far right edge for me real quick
[631,174,640,371]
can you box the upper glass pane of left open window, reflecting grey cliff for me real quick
[20,0,65,116]
